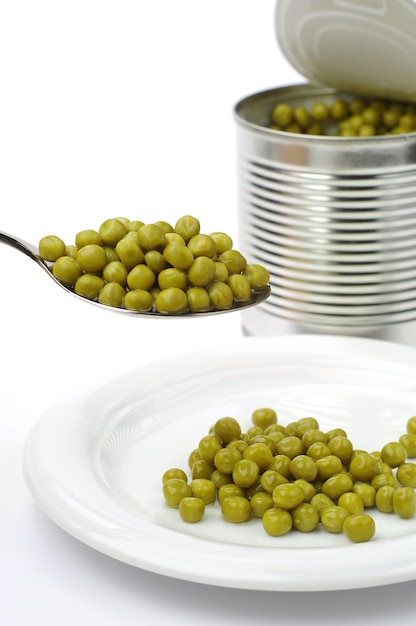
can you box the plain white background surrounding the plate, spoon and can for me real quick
[0,0,416,626]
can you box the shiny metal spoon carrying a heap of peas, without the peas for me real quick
[0,230,270,318]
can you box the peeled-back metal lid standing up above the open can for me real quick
[274,0,416,102]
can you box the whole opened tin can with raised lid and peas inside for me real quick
[234,0,416,345]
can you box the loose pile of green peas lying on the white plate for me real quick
[162,408,416,543]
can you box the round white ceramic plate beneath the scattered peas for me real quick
[24,335,416,591]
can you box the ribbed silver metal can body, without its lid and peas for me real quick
[235,84,416,343]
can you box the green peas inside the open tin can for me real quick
[269,98,416,137]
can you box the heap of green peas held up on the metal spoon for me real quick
[39,215,270,315]
